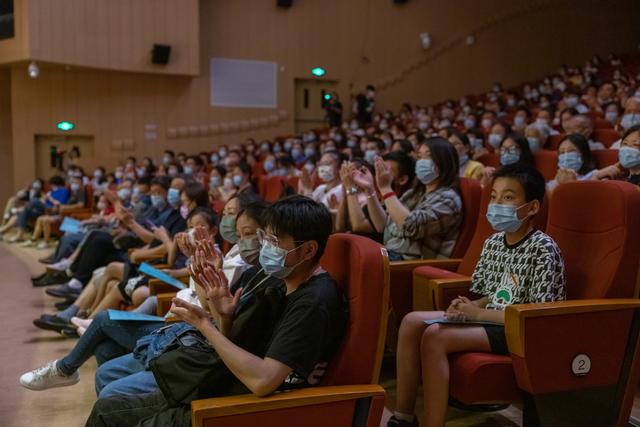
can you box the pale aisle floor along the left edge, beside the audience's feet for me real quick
[0,243,95,427]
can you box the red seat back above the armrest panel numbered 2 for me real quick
[547,181,640,299]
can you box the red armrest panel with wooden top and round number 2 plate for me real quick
[505,299,640,394]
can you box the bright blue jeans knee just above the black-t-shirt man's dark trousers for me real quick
[96,353,159,399]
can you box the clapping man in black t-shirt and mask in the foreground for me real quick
[87,196,347,426]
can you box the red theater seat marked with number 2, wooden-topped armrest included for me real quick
[438,181,640,426]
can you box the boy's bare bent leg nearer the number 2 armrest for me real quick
[420,324,491,427]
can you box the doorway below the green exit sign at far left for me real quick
[35,135,96,180]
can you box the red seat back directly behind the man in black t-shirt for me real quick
[320,233,389,385]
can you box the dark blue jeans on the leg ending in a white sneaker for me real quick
[57,311,164,375]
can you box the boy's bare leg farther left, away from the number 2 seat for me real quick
[396,311,444,415]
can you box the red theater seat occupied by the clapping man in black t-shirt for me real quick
[191,234,389,427]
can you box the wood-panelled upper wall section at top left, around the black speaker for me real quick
[23,0,199,75]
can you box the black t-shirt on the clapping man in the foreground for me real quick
[265,273,347,389]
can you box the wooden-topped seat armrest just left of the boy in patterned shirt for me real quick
[413,274,471,311]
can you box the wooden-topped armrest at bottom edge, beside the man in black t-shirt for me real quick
[191,384,385,427]
